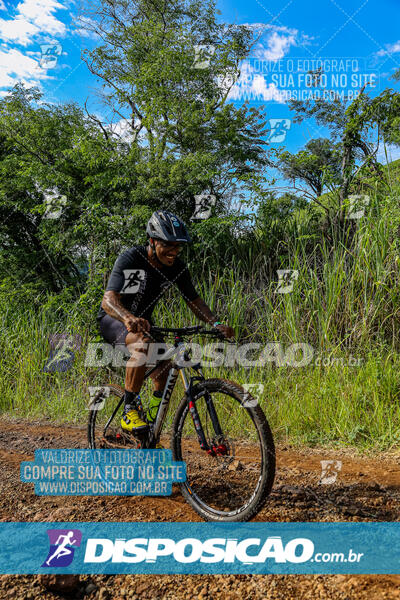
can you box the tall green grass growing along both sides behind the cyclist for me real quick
[0,180,400,449]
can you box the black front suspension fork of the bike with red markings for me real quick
[180,369,227,456]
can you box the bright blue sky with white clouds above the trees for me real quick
[0,0,400,168]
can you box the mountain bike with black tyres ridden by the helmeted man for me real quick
[88,326,275,522]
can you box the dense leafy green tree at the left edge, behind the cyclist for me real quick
[0,85,150,292]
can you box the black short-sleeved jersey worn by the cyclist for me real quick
[97,246,199,320]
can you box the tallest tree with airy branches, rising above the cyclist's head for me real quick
[77,0,268,219]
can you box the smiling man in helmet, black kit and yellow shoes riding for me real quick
[97,210,234,434]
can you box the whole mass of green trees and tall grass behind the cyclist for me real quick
[0,0,400,447]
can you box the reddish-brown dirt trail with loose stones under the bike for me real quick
[0,418,400,600]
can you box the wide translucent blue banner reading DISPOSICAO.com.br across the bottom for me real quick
[0,522,400,574]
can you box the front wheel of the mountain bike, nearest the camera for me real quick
[171,379,275,522]
